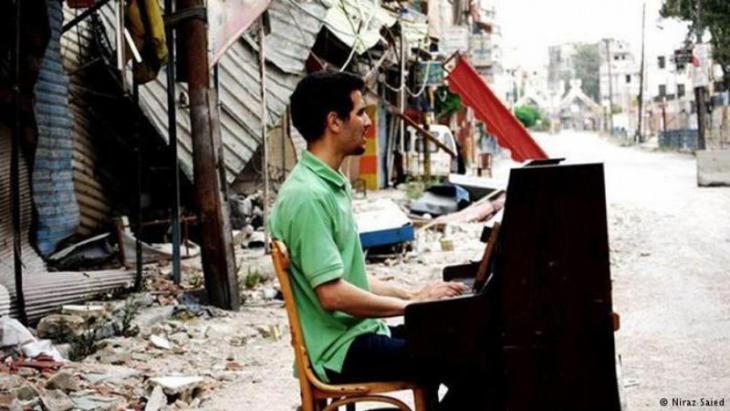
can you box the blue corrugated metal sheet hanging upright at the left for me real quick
[32,0,79,256]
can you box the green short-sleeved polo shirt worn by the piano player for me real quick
[269,151,389,381]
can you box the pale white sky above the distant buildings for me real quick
[486,0,687,68]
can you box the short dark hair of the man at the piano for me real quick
[289,71,365,142]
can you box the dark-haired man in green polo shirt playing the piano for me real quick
[269,72,465,394]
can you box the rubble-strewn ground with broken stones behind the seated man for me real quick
[0,190,490,411]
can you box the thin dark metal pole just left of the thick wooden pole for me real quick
[165,0,181,284]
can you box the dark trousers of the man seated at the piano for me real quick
[326,325,483,411]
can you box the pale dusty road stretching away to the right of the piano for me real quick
[537,132,730,410]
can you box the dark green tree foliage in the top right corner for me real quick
[660,0,730,90]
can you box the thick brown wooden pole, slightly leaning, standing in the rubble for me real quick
[179,0,240,310]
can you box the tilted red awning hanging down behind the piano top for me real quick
[448,56,548,162]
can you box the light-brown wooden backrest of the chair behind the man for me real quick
[271,240,316,410]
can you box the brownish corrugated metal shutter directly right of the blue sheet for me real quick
[61,3,112,237]
